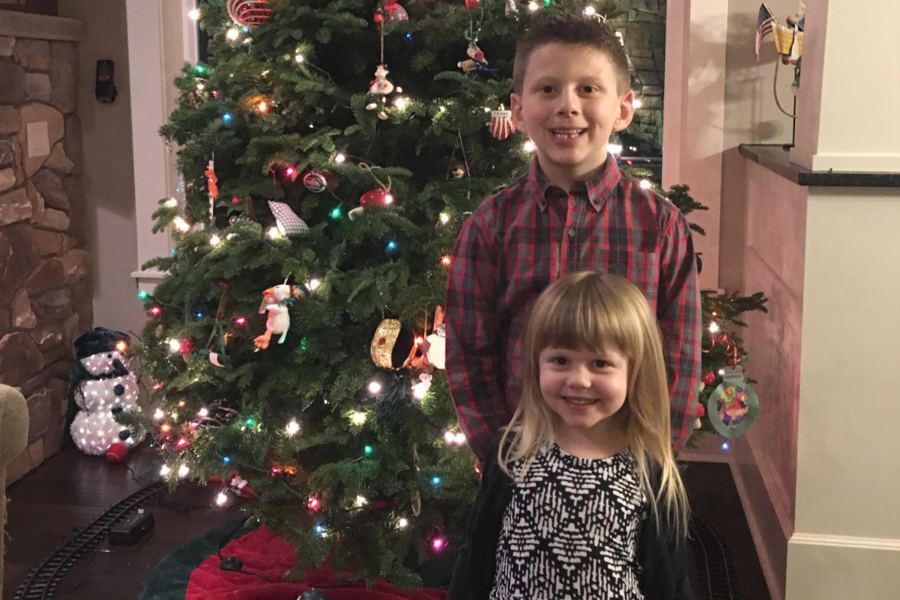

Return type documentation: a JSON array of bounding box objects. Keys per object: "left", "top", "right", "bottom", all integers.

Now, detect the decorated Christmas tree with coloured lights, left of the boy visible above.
[{"left": 132, "top": 0, "right": 768, "bottom": 586}]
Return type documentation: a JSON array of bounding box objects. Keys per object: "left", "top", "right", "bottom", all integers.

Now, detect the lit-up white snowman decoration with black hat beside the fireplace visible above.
[{"left": 69, "top": 327, "right": 145, "bottom": 463}]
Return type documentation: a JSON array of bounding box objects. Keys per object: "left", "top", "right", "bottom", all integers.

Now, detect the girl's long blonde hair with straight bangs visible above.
[{"left": 498, "top": 271, "right": 689, "bottom": 534}]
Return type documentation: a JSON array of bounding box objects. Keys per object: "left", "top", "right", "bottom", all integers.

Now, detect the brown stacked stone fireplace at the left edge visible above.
[{"left": 0, "top": 37, "right": 93, "bottom": 481}]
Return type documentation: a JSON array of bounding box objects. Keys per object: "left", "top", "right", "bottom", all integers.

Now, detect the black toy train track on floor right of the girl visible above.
[{"left": 688, "top": 514, "right": 741, "bottom": 600}]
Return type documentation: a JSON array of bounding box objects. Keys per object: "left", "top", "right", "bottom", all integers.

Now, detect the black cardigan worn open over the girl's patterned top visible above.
[{"left": 446, "top": 436, "right": 694, "bottom": 600}]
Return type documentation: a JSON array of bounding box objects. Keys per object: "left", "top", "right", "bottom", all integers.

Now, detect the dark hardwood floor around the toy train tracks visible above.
[{"left": 3, "top": 444, "right": 769, "bottom": 600}]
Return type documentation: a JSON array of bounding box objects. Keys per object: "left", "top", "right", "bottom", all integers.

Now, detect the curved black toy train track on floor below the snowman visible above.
[{"left": 14, "top": 482, "right": 165, "bottom": 600}]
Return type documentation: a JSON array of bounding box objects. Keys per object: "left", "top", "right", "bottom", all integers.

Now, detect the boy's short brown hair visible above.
[{"left": 513, "top": 13, "right": 631, "bottom": 94}]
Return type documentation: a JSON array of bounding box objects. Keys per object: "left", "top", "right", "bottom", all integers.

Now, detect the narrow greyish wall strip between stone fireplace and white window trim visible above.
[{"left": 59, "top": 0, "right": 145, "bottom": 332}]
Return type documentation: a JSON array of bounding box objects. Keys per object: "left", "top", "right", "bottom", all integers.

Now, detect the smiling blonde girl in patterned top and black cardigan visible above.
[{"left": 447, "top": 272, "right": 693, "bottom": 600}]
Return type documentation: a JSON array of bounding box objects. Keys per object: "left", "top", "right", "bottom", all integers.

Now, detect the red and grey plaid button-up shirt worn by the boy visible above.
[{"left": 445, "top": 156, "right": 701, "bottom": 458}]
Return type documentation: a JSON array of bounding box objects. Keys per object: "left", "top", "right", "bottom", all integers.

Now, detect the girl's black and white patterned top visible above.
[{"left": 491, "top": 444, "right": 647, "bottom": 600}]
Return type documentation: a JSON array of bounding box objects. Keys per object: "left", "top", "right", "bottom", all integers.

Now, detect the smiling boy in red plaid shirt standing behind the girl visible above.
[{"left": 445, "top": 15, "right": 701, "bottom": 460}]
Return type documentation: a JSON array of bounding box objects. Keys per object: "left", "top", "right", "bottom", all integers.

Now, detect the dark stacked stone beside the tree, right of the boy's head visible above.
[{"left": 609, "top": 0, "right": 666, "bottom": 154}]
